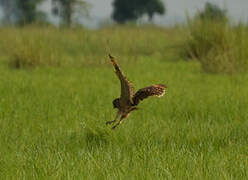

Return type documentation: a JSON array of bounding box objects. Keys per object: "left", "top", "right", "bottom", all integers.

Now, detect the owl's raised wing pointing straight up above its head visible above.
[{"left": 109, "top": 54, "right": 134, "bottom": 104}]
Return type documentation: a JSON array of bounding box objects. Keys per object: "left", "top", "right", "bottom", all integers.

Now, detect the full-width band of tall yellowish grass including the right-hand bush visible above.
[{"left": 0, "top": 19, "right": 248, "bottom": 74}]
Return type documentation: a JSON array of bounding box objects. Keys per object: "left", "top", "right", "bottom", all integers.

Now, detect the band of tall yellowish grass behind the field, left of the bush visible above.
[{"left": 0, "top": 26, "right": 181, "bottom": 68}]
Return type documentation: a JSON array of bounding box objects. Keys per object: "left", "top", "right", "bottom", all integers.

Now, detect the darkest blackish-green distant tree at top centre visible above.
[{"left": 112, "top": 0, "right": 166, "bottom": 23}]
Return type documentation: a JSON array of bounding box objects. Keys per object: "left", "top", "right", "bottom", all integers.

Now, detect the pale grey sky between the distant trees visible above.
[{"left": 0, "top": 0, "right": 248, "bottom": 28}]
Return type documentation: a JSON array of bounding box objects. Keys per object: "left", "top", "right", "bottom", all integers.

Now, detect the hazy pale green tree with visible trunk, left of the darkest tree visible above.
[{"left": 52, "top": 0, "right": 89, "bottom": 26}]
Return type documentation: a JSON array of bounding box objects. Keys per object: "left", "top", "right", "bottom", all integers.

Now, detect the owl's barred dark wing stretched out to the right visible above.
[{"left": 133, "top": 84, "right": 167, "bottom": 106}]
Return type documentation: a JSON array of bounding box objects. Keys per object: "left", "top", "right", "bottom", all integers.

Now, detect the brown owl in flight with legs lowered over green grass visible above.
[{"left": 106, "top": 55, "right": 167, "bottom": 129}]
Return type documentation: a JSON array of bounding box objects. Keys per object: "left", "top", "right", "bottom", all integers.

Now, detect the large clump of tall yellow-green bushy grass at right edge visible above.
[{"left": 184, "top": 18, "right": 248, "bottom": 73}]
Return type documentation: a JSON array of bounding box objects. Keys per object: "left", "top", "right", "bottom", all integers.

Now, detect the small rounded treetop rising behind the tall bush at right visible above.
[{"left": 199, "top": 2, "right": 227, "bottom": 20}]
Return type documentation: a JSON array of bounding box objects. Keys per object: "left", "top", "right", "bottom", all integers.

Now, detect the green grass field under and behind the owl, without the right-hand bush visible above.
[{"left": 0, "top": 28, "right": 248, "bottom": 180}]
